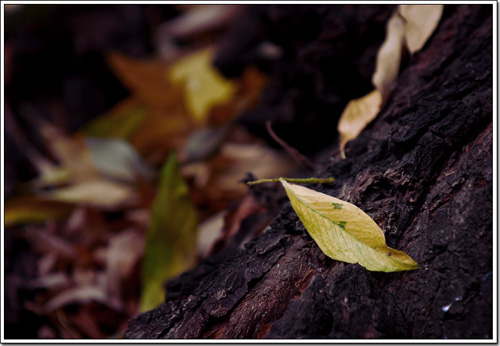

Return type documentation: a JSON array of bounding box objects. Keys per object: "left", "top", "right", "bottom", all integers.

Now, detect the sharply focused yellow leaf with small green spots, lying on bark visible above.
[{"left": 280, "top": 179, "right": 419, "bottom": 272}]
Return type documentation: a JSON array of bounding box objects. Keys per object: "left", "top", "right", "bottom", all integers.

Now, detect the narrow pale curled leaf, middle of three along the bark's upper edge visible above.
[{"left": 372, "top": 12, "right": 405, "bottom": 101}]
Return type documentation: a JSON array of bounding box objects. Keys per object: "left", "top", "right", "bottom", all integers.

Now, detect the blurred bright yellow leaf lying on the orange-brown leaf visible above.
[{"left": 169, "top": 50, "right": 234, "bottom": 122}]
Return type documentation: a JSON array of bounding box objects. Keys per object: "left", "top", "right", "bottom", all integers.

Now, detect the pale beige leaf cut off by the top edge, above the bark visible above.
[{"left": 399, "top": 5, "right": 444, "bottom": 54}]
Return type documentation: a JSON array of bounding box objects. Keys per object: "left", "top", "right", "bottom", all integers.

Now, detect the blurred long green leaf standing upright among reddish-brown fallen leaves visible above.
[{"left": 140, "top": 153, "right": 198, "bottom": 311}]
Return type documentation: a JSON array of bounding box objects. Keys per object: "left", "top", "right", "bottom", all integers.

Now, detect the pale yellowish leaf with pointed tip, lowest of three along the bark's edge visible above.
[{"left": 337, "top": 90, "right": 382, "bottom": 158}]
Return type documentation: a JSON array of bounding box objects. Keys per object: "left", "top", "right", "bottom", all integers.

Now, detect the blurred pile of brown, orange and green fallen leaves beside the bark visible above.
[{"left": 5, "top": 6, "right": 293, "bottom": 338}]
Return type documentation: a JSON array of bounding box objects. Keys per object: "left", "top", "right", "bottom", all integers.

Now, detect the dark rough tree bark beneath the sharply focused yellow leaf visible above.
[{"left": 125, "top": 5, "right": 493, "bottom": 338}]
